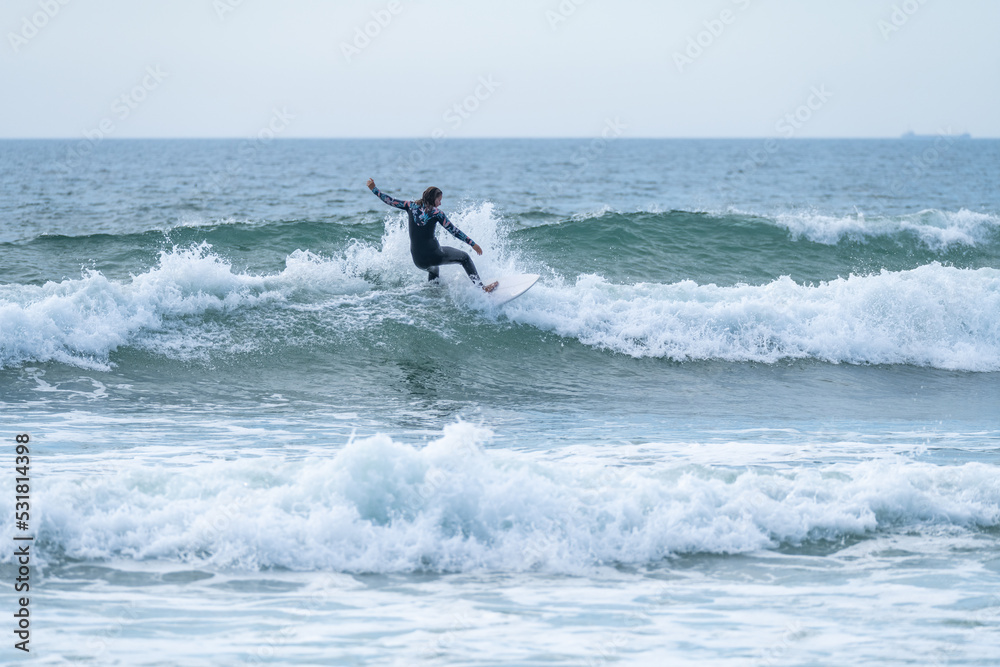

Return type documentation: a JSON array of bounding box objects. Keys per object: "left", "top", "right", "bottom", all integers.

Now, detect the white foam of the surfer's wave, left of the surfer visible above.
[{"left": 0, "top": 243, "right": 370, "bottom": 370}]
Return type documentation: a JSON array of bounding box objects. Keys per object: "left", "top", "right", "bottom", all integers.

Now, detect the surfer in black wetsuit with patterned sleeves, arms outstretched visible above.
[{"left": 367, "top": 178, "right": 498, "bottom": 292}]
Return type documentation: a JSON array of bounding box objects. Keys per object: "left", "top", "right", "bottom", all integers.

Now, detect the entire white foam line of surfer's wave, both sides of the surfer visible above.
[{"left": 0, "top": 202, "right": 1000, "bottom": 371}]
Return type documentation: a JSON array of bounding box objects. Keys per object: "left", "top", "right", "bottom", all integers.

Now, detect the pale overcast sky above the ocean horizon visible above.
[{"left": 0, "top": 0, "right": 1000, "bottom": 138}]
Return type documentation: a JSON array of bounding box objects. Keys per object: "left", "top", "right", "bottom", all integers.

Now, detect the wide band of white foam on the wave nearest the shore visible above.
[{"left": 0, "top": 423, "right": 1000, "bottom": 572}]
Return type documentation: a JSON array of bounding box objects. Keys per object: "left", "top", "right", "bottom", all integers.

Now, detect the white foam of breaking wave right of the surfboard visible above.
[{"left": 505, "top": 263, "right": 1000, "bottom": 371}]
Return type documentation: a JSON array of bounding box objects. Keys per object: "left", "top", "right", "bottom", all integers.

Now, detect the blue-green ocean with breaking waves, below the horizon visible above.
[{"left": 0, "top": 134, "right": 1000, "bottom": 665}]
